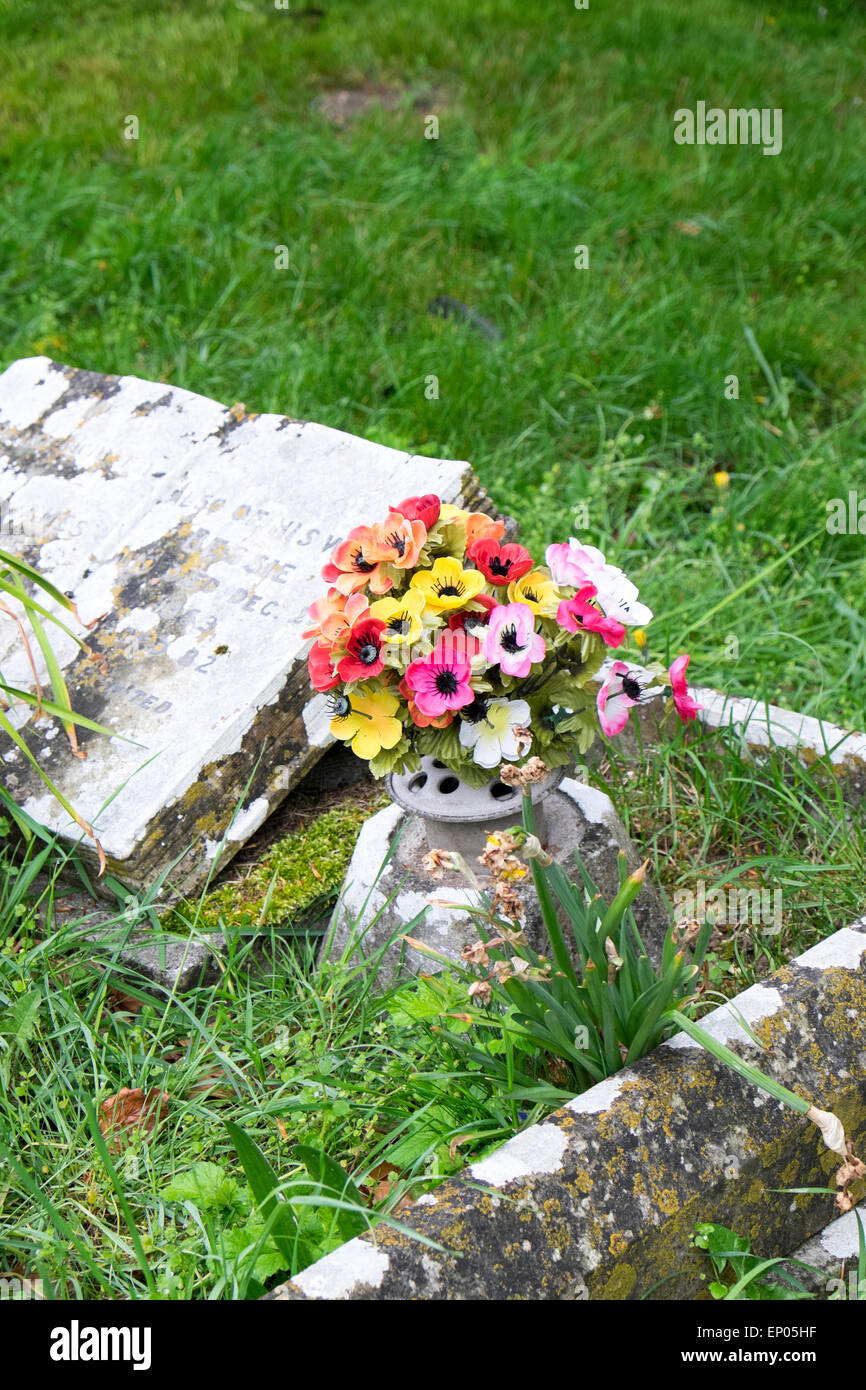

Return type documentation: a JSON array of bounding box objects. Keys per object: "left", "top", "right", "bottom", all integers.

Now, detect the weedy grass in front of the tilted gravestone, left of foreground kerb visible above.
[{"left": 0, "top": 824, "right": 549, "bottom": 1298}]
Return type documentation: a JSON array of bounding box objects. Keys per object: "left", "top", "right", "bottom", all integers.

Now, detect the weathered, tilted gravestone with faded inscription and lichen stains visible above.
[{"left": 0, "top": 357, "right": 485, "bottom": 891}]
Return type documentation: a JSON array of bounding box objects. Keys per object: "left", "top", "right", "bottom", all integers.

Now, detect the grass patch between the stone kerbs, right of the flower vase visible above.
[{"left": 592, "top": 730, "right": 866, "bottom": 995}]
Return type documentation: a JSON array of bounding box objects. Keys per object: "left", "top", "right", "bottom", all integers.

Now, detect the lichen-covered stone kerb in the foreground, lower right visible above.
[{"left": 265, "top": 919, "right": 866, "bottom": 1300}]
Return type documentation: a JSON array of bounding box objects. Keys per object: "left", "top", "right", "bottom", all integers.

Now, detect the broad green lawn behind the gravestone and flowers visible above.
[{"left": 0, "top": 0, "right": 866, "bottom": 726}]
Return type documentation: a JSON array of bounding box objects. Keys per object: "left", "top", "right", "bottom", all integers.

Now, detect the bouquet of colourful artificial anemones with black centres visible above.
[{"left": 304, "top": 493, "right": 699, "bottom": 785}]
